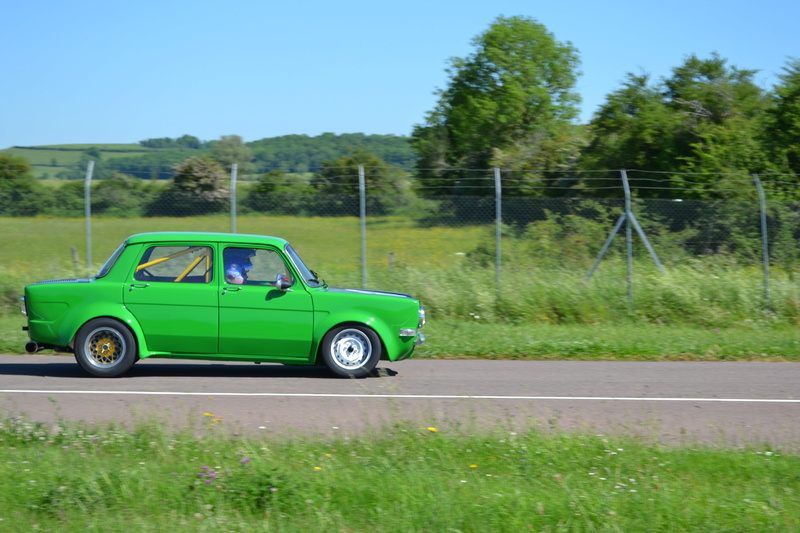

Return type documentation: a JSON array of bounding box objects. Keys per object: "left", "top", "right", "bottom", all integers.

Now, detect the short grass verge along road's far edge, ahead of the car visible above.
[{"left": 414, "top": 320, "right": 800, "bottom": 361}]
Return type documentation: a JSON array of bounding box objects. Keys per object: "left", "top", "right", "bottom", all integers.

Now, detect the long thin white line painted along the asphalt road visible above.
[{"left": 0, "top": 389, "right": 800, "bottom": 403}]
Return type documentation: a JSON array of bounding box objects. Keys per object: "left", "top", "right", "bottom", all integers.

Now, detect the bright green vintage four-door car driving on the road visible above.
[{"left": 23, "top": 232, "right": 425, "bottom": 378}]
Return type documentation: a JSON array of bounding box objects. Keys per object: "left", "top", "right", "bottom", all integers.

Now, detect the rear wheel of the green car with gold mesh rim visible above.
[{"left": 75, "top": 318, "right": 138, "bottom": 378}]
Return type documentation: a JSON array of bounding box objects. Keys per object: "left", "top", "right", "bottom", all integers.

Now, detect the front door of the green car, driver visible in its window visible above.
[{"left": 219, "top": 246, "right": 313, "bottom": 360}]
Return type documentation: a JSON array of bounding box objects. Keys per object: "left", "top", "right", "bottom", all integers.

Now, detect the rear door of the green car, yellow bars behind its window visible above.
[{"left": 123, "top": 243, "right": 219, "bottom": 354}]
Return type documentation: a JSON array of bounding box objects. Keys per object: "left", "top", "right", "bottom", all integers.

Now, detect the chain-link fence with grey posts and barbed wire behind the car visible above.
[{"left": 0, "top": 163, "right": 800, "bottom": 310}]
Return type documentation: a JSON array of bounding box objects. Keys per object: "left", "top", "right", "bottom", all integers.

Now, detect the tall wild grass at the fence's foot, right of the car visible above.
[{"left": 373, "top": 259, "right": 800, "bottom": 328}]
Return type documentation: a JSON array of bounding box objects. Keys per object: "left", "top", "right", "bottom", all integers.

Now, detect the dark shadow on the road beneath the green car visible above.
[{"left": 0, "top": 360, "right": 397, "bottom": 381}]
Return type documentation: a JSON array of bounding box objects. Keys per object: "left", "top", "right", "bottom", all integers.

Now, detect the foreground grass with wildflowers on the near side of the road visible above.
[{"left": 0, "top": 415, "right": 800, "bottom": 533}]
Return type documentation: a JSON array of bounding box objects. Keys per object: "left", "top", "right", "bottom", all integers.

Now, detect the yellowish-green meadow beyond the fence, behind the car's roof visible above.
[{"left": 0, "top": 215, "right": 485, "bottom": 278}]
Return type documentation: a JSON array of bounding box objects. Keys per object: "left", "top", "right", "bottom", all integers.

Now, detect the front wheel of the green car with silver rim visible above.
[{"left": 322, "top": 326, "right": 383, "bottom": 378}]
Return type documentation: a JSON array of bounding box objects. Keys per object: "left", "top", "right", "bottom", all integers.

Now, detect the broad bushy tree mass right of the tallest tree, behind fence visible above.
[{"left": 581, "top": 53, "right": 768, "bottom": 198}]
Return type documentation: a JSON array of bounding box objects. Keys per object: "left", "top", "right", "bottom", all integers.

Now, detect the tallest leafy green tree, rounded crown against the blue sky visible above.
[{"left": 412, "top": 17, "right": 579, "bottom": 195}]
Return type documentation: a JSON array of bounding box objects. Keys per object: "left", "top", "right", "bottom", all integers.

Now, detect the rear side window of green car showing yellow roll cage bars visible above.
[{"left": 133, "top": 246, "right": 213, "bottom": 283}]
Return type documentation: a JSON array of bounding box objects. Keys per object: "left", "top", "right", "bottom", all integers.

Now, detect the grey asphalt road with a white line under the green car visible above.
[{"left": 0, "top": 355, "right": 800, "bottom": 449}]
